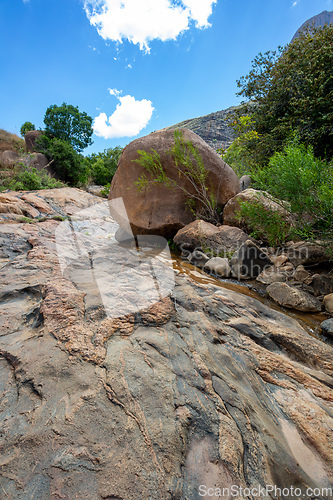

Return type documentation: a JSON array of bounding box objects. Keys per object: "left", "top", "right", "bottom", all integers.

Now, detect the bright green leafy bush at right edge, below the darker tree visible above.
[{"left": 240, "top": 140, "right": 333, "bottom": 244}]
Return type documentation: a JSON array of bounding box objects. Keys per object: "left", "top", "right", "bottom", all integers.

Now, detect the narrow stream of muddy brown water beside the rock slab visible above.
[{"left": 172, "top": 255, "right": 333, "bottom": 345}]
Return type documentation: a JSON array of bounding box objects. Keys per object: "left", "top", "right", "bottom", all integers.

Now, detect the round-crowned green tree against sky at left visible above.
[{"left": 44, "top": 102, "right": 93, "bottom": 152}]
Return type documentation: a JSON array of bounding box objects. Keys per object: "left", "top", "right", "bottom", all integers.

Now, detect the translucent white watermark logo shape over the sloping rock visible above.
[{"left": 55, "top": 198, "right": 175, "bottom": 319}]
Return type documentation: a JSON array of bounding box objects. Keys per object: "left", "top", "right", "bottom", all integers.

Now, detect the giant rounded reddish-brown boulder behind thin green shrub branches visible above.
[{"left": 109, "top": 129, "right": 240, "bottom": 238}]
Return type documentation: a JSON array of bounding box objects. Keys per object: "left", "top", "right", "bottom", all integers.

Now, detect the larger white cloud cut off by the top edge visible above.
[{"left": 84, "top": 0, "right": 217, "bottom": 52}]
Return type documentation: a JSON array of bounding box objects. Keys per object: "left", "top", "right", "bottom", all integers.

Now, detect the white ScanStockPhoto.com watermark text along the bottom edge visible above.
[{"left": 199, "top": 484, "right": 333, "bottom": 500}]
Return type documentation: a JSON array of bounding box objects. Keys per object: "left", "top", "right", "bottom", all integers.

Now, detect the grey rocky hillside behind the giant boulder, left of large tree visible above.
[{"left": 167, "top": 106, "right": 235, "bottom": 150}]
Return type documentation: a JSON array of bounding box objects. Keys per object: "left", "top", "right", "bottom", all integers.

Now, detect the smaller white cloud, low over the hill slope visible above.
[{"left": 93, "top": 89, "right": 154, "bottom": 139}]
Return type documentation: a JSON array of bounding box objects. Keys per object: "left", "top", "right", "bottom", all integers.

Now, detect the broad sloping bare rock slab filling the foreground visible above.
[{"left": 0, "top": 188, "right": 333, "bottom": 500}]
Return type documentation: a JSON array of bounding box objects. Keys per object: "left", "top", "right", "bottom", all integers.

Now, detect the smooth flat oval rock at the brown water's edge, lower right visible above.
[{"left": 266, "top": 283, "right": 321, "bottom": 312}]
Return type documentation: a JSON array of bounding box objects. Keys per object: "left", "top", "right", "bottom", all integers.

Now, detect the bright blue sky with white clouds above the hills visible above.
[{"left": 0, "top": 0, "right": 333, "bottom": 154}]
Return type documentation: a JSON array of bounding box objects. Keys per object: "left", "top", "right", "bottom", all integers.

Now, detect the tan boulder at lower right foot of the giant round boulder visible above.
[{"left": 173, "top": 220, "right": 249, "bottom": 256}]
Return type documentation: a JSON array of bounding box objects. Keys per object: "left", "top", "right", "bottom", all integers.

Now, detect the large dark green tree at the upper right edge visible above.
[{"left": 232, "top": 25, "right": 333, "bottom": 165}]
